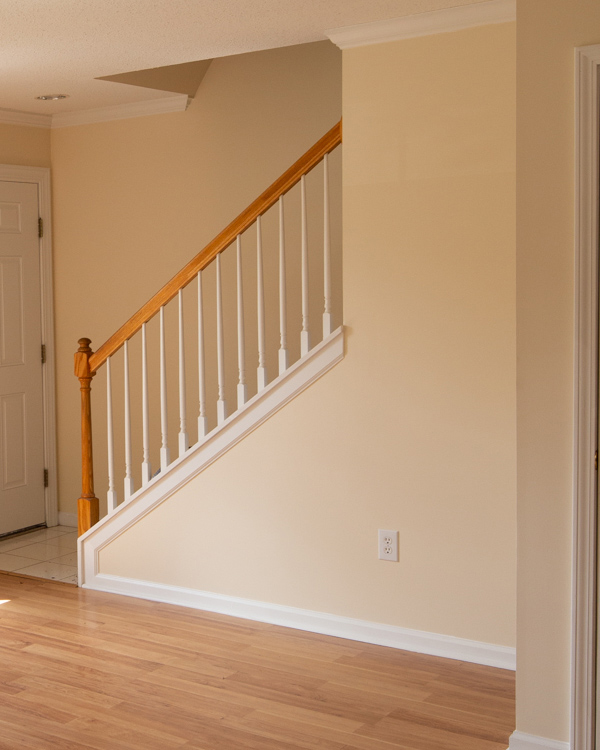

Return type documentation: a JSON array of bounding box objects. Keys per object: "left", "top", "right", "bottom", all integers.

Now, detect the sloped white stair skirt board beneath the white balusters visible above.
[{"left": 77, "top": 326, "right": 344, "bottom": 588}]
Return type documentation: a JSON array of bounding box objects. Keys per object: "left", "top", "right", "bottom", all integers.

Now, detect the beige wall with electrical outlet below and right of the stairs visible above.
[{"left": 100, "top": 24, "right": 516, "bottom": 646}]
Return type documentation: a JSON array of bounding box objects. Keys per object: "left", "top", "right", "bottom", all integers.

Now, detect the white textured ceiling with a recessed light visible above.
[{"left": 0, "top": 0, "right": 481, "bottom": 114}]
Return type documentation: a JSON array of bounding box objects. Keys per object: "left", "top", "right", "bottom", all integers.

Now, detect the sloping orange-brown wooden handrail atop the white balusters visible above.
[{"left": 89, "top": 120, "right": 342, "bottom": 371}]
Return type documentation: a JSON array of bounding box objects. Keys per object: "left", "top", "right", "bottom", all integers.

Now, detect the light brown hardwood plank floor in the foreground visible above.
[{"left": 0, "top": 574, "right": 514, "bottom": 750}]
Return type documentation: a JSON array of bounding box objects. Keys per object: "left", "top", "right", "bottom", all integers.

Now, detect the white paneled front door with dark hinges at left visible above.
[{"left": 0, "top": 182, "right": 46, "bottom": 534}]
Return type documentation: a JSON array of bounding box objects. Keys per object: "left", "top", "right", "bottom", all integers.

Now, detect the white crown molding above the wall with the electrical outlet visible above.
[{"left": 325, "top": 0, "right": 517, "bottom": 49}]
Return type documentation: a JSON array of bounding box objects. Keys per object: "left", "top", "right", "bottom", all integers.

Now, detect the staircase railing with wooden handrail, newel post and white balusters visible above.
[{"left": 75, "top": 122, "right": 342, "bottom": 535}]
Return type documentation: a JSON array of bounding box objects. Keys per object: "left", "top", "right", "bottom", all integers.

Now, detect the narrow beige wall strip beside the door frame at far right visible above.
[{"left": 517, "top": 0, "right": 600, "bottom": 741}]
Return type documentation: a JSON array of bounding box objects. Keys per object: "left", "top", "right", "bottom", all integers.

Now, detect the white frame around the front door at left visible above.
[{"left": 0, "top": 164, "right": 58, "bottom": 526}]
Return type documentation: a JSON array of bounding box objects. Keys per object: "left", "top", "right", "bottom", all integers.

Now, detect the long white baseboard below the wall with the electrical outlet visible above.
[{"left": 84, "top": 573, "right": 516, "bottom": 672}]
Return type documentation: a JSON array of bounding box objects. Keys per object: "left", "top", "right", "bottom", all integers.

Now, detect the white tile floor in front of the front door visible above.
[{"left": 0, "top": 526, "right": 77, "bottom": 583}]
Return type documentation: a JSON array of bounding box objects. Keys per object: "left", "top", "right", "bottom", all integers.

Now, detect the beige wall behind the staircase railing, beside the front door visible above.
[{"left": 52, "top": 42, "right": 341, "bottom": 512}]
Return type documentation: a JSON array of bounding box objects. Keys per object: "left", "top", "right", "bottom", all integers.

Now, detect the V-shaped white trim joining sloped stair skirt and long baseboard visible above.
[{"left": 78, "top": 327, "right": 516, "bottom": 670}]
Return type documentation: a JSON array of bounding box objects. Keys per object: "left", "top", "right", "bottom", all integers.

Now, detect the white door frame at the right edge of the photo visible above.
[{"left": 571, "top": 44, "right": 600, "bottom": 750}]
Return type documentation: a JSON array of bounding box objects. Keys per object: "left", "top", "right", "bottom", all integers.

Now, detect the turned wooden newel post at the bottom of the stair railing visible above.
[{"left": 75, "top": 339, "right": 100, "bottom": 536}]
